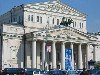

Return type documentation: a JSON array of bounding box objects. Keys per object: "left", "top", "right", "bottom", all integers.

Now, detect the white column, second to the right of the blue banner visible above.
[{"left": 78, "top": 43, "right": 83, "bottom": 69}]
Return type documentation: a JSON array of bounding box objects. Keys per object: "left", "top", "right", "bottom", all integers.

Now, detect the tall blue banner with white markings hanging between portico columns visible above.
[{"left": 65, "top": 48, "right": 72, "bottom": 70}]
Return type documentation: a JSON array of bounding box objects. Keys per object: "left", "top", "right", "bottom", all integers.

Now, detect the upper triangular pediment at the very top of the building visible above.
[{"left": 26, "top": 1, "right": 86, "bottom": 16}]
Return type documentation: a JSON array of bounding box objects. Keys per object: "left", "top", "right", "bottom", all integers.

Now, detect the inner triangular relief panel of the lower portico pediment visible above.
[{"left": 48, "top": 28, "right": 89, "bottom": 40}]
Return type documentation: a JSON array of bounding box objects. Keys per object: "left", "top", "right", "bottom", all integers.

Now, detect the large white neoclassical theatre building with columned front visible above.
[{"left": 0, "top": 0, "right": 100, "bottom": 70}]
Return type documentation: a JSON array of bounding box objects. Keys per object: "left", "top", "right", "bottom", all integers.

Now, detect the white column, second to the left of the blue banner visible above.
[{"left": 52, "top": 41, "right": 56, "bottom": 69}]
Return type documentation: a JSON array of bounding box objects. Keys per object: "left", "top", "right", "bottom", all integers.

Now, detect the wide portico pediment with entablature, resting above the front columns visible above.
[{"left": 28, "top": 27, "right": 97, "bottom": 43}]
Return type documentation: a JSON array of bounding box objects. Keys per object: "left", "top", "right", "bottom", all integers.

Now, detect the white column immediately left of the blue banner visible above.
[{"left": 61, "top": 42, "right": 65, "bottom": 70}]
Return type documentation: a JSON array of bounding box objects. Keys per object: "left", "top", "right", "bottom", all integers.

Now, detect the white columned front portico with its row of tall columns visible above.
[{"left": 27, "top": 26, "right": 95, "bottom": 70}]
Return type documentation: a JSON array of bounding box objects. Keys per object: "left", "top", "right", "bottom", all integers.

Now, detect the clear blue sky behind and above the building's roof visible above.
[{"left": 0, "top": 0, "right": 100, "bottom": 32}]
